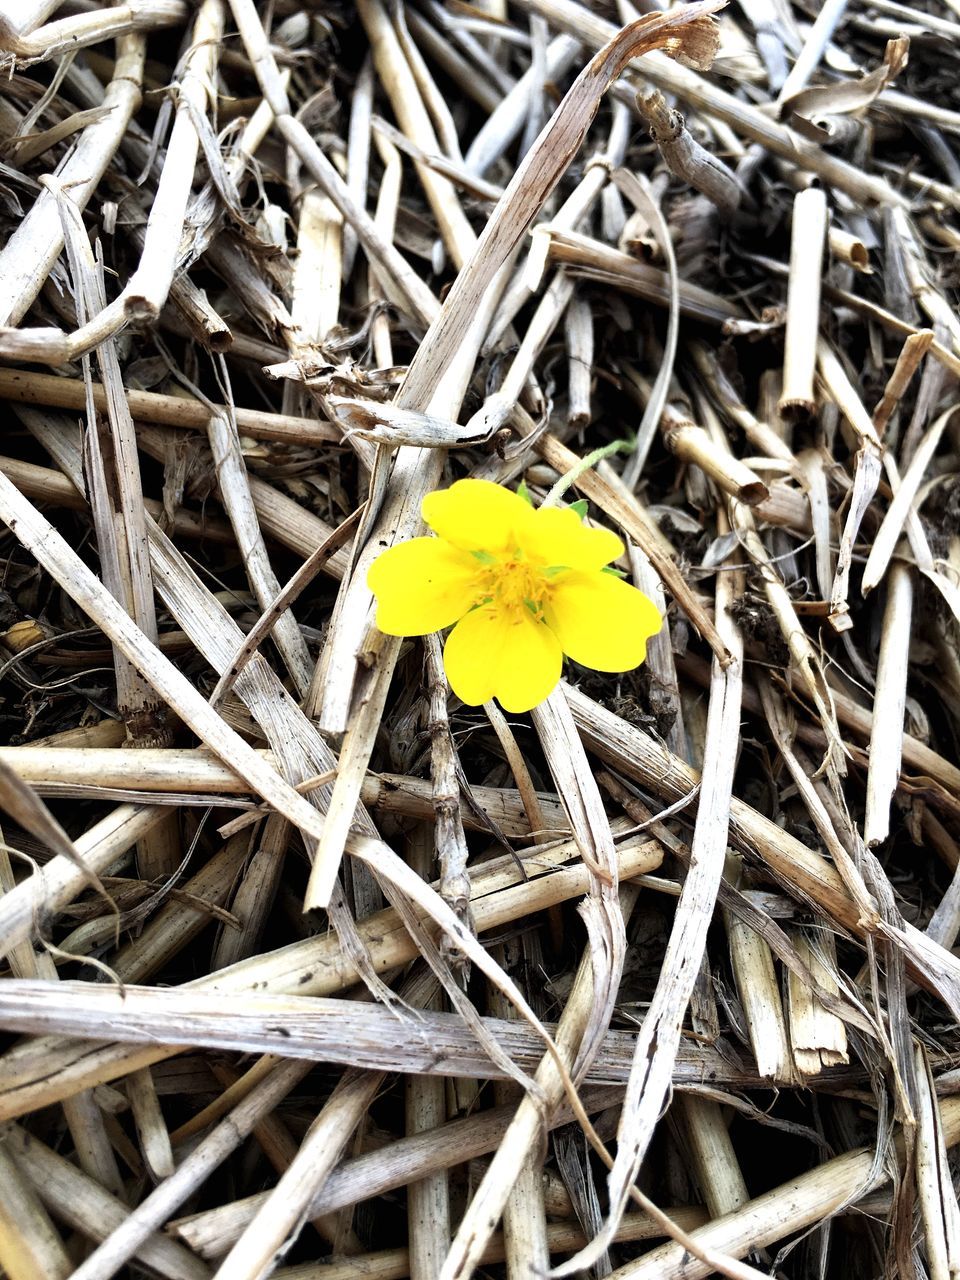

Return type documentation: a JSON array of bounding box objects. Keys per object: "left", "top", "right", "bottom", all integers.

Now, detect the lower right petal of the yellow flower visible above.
[{"left": 544, "top": 572, "right": 663, "bottom": 671}]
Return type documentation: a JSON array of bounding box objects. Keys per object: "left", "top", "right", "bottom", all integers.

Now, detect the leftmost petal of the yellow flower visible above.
[{"left": 366, "top": 538, "right": 479, "bottom": 636}]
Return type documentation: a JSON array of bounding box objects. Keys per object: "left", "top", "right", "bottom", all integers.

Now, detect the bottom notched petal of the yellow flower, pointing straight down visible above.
[{"left": 443, "top": 605, "right": 563, "bottom": 712}]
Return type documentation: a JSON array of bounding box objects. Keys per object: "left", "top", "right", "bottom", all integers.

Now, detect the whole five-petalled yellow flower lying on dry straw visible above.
[{"left": 367, "top": 480, "right": 662, "bottom": 712}]
